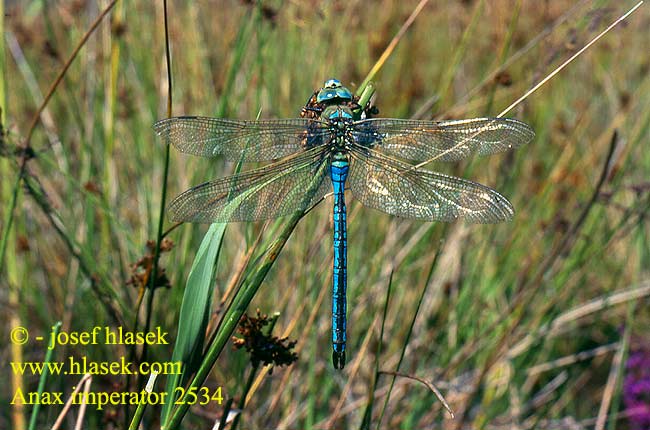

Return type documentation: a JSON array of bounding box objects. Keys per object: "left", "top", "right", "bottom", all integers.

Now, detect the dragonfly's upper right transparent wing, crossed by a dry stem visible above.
[{"left": 353, "top": 118, "right": 535, "bottom": 162}]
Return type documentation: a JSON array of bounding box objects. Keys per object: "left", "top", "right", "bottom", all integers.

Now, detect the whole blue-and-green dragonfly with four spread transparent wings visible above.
[{"left": 153, "top": 79, "right": 535, "bottom": 369}]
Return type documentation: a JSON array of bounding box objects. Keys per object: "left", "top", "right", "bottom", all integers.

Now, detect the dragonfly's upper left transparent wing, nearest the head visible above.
[{"left": 153, "top": 116, "right": 329, "bottom": 162}]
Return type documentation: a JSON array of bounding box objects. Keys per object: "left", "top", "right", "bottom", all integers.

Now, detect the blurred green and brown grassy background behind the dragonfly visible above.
[{"left": 0, "top": 0, "right": 650, "bottom": 429}]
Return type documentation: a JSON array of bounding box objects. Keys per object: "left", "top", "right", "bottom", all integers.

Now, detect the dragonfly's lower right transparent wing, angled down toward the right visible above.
[{"left": 348, "top": 146, "right": 514, "bottom": 224}]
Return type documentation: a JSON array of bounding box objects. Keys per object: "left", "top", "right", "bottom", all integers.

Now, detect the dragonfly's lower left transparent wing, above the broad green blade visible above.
[{"left": 167, "top": 148, "right": 331, "bottom": 223}]
